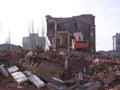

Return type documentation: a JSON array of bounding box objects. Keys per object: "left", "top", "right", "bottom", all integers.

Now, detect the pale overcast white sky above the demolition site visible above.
[{"left": 0, "top": 0, "right": 120, "bottom": 50}]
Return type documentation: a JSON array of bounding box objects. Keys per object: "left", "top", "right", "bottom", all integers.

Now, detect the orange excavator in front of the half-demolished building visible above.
[{"left": 72, "top": 32, "right": 89, "bottom": 50}]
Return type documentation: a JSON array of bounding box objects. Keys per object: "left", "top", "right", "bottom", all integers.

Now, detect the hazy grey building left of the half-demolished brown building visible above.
[{"left": 23, "top": 33, "right": 46, "bottom": 50}]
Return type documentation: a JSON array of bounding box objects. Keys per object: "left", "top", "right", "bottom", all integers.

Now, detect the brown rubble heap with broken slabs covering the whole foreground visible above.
[{"left": 0, "top": 48, "right": 120, "bottom": 90}]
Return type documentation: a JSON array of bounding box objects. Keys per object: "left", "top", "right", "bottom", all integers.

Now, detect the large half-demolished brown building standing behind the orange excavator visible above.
[{"left": 46, "top": 14, "right": 96, "bottom": 52}]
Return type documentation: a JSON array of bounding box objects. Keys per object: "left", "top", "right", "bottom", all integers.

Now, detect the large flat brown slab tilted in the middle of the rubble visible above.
[{"left": 31, "top": 60, "right": 64, "bottom": 82}]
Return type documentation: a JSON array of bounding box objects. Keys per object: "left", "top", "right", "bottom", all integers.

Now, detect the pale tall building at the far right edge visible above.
[{"left": 113, "top": 33, "right": 120, "bottom": 51}]
